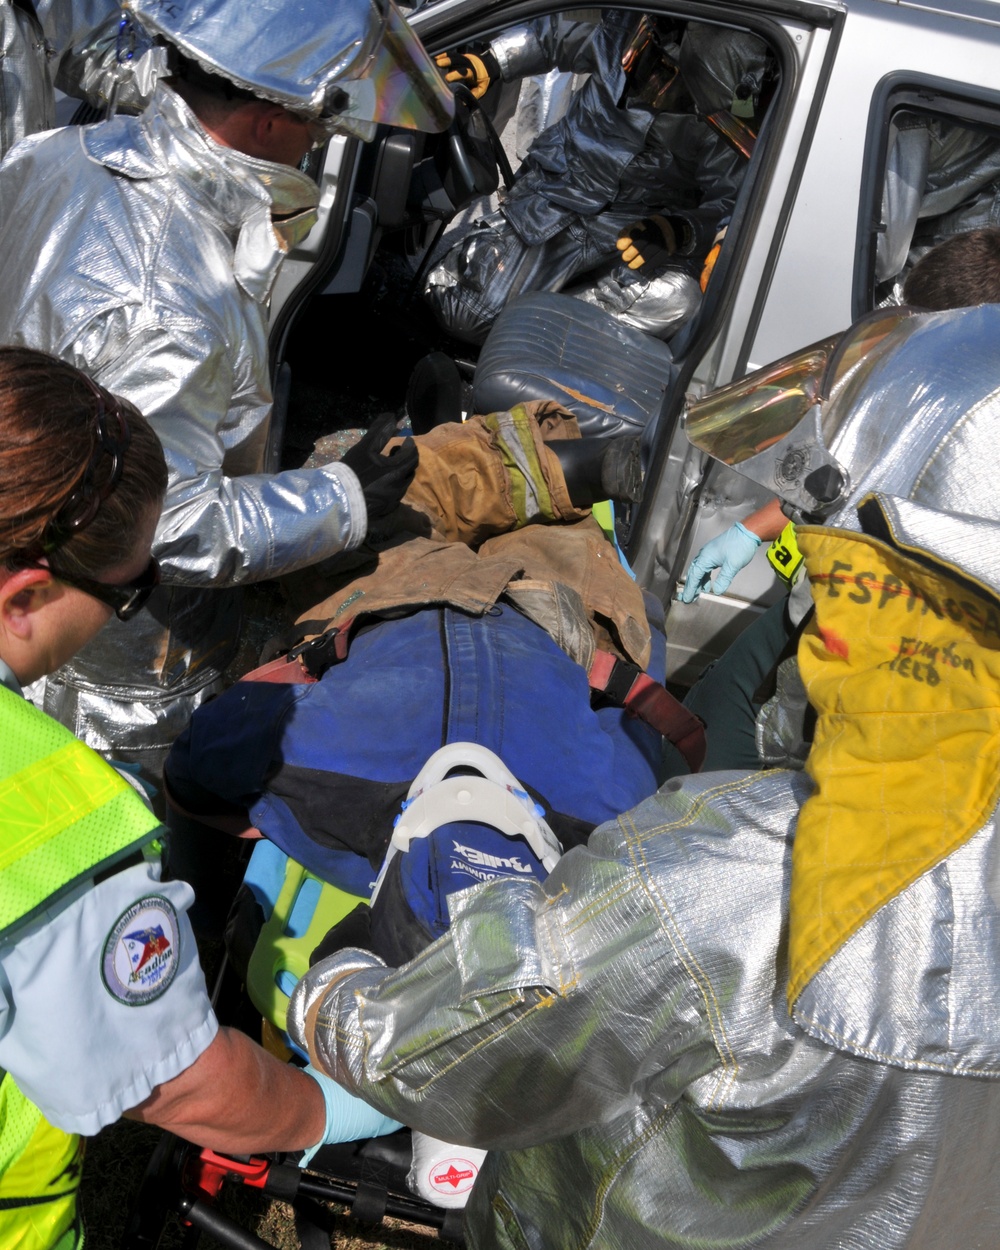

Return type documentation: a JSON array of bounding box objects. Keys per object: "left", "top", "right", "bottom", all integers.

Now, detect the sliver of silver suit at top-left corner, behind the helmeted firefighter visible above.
[{"left": 0, "top": 0, "right": 55, "bottom": 156}]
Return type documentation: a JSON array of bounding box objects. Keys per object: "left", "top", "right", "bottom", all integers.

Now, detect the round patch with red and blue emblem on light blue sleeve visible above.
[{"left": 101, "top": 894, "right": 180, "bottom": 1008}]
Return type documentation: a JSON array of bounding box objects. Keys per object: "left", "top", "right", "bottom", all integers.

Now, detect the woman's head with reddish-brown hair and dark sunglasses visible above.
[{"left": 0, "top": 348, "right": 166, "bottom": 681}]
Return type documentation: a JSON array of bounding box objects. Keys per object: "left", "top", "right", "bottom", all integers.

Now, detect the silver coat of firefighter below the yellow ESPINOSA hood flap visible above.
[{"left": 289, "top": 755, "right": 1000, "bottom": 1250}]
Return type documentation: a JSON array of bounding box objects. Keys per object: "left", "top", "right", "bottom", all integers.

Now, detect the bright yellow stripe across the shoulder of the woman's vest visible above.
[{"left": 0, "top": 739, "right": 123, "bottom": 873}]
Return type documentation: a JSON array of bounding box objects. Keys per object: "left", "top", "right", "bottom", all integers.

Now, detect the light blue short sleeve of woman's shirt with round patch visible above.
[{"left": 0, "top": 661, "right": 219, "bottom": 1136}]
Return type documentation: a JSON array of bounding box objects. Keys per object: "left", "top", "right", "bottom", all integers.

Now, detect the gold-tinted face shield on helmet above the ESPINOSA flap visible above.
[{"left": 685, "top": 308, "right": 916, "bottom": 518}]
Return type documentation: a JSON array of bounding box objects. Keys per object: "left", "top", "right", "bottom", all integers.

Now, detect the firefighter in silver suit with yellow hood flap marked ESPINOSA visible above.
[{"left": 289, "top": 305, "right": 1000, "bottom": 1250}]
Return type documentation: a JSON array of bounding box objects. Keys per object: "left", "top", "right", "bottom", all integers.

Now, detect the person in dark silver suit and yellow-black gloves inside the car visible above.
[{"left": 425, "top": 10, "right": 768, "bottom": 343}]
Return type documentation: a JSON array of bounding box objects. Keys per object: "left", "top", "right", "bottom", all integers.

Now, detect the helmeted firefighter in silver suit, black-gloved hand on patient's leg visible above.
[{"left": 0, "top": 0, "right": 453, "bottom": 776}]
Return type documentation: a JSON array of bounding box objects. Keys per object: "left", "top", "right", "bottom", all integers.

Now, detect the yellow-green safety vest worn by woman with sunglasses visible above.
[{"left": 0, "top": 688, "right": 158, "bottom": 1250}]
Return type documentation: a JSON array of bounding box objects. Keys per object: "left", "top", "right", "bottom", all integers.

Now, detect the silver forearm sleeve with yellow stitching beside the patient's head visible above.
[{"left": 295, "top": 826, "right": 718, "bottom": 1149}]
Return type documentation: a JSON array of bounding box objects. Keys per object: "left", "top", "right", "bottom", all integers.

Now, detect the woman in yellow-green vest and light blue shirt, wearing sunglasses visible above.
[{"left": 0, "top": 348, "right": 396, "bottom": 1250}]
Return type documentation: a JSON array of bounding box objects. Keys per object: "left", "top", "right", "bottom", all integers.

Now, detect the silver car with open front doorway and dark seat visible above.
[{"left": 271, "top": 0, "right": 1000, "bottom": 685}]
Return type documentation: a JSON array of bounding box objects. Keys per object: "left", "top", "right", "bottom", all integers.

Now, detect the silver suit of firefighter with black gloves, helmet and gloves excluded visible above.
[{"left": 0, "top": 85, "right": 366, "bottom": 750}]
